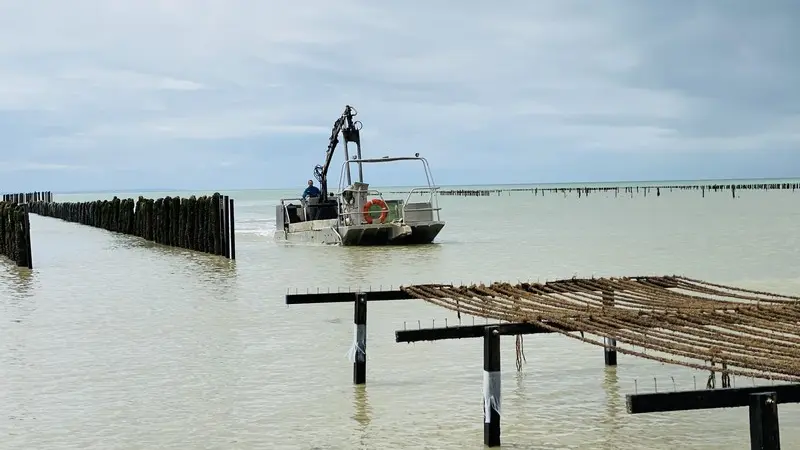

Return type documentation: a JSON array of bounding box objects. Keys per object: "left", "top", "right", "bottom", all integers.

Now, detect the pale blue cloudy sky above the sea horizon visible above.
[{"left": 0, "top": 0, "right": 800, "bottom": 192}]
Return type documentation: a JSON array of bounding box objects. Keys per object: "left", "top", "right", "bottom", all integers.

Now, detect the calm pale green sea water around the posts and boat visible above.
[{"left": 0, "top": 178, "right": 800, "bottom": 450}]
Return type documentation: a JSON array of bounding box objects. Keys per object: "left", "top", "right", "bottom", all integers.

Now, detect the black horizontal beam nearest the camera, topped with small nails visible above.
[{"left": 626, "top": 383, "right": 800, "bottom": 414}]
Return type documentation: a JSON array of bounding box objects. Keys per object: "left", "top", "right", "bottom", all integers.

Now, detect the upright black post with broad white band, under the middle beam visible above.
[{"left": 483, "top": 326, "right": 501, "bottom": 447}]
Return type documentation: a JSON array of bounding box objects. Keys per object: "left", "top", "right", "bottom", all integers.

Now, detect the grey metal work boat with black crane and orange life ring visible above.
[{"left": 275, "top": 105, "right": 445, "bottom": 246}]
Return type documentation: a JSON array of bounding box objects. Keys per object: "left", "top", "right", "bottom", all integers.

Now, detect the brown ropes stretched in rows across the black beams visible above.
[{"left": 401, "top": 276, "right": 800, "bottom": 381}]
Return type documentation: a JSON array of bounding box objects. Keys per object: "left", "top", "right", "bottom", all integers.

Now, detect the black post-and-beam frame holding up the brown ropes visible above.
[{"left": 286, "top": 276, "right": 800, "bottom": 450}]
